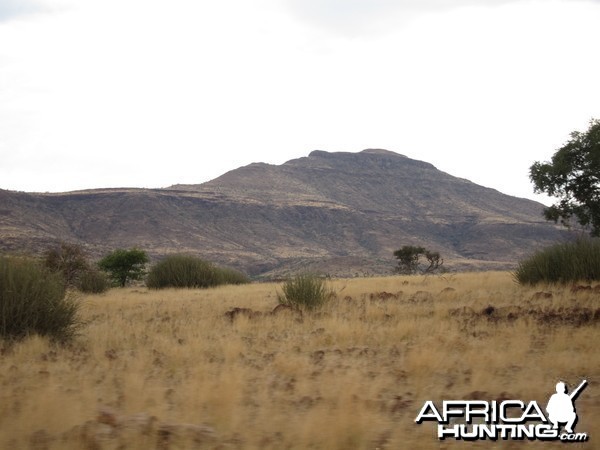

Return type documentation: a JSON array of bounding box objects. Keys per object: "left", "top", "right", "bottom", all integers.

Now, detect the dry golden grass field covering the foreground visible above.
[{"left": 0, "top": 272, "right": 600, "bottom": 450}]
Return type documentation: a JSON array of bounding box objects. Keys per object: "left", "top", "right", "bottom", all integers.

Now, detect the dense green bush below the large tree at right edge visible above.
[{"left": 514, "top": 238, "right": 600, "bottom": 284}]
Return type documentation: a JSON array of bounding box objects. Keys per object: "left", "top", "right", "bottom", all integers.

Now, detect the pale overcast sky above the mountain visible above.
[{"left": 0, "top": 0, "right": 600, "bottom": 199}]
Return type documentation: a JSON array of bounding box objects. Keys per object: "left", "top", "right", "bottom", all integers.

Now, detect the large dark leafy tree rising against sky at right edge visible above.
[{"left": 529, "top": 119, "right": 600, "bottom": 237}]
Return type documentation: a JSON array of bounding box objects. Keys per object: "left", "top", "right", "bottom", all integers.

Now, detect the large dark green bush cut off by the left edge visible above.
[{"left": 0, "top": 257, "right": 79, "bottom": 342}]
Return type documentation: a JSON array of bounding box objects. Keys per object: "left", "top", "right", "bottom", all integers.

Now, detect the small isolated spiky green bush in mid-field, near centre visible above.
[{"left": 277, "top": 273, "right": 333, "bottom": 310}]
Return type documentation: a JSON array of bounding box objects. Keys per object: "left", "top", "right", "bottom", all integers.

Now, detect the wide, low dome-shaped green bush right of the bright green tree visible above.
[{"left": 146, "top": 255, "right": 250, "bottom": 289}]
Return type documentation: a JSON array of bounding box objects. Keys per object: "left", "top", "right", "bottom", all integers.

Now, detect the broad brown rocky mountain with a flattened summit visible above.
[{"left": 0, "top": 149, "right": 561, "bottom": 276}]
